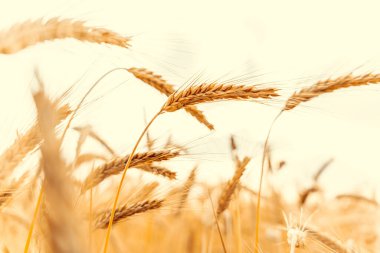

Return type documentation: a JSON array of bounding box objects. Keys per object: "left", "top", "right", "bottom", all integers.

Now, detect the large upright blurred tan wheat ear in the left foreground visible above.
[{"left": 33, "top": 88, "right": 85, "bottom": 253}]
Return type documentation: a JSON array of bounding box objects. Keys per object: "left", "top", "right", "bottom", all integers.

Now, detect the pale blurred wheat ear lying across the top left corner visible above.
[{"left": 0, "top": 17, "right": 130, "bottom": 54}]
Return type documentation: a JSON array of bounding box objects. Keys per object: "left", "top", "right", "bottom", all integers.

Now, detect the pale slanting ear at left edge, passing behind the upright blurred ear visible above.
[{"left": 0, "top": 102, "right": 71, "bottom": 180}]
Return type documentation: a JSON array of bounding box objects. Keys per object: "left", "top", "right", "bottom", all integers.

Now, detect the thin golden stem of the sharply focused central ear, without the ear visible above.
[{"left": 103, "top": 110, "right": 162, "bottom": 253}]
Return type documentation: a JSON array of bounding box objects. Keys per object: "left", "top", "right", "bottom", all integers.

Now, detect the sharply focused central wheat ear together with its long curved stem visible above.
[{"left": 103, "top": 83, "right": 278, "bottom": 253}]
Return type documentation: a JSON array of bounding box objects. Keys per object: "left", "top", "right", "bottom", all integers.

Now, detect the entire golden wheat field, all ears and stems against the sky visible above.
[{"left": 0, "top": 1, "right": 380, "bottom": 253}]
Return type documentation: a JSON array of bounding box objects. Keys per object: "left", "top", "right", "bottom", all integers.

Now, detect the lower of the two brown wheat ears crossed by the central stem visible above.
[{"left": 95, "top": 200, "right": 164, "bottom": 229}]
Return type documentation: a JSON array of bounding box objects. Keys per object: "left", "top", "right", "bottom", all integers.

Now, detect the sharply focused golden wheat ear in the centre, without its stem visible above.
[{"left": 162, "top": 83, "right": 278, "bottom": 112}]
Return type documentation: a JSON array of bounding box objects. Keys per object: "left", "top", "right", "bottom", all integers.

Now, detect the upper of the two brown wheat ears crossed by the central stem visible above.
[{"left": 82, "top": 150, "right": 179, "bottom": 192}]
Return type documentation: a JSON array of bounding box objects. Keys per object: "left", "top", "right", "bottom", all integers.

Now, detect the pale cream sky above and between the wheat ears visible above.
[{"left": 0, "top": 0, "right": 380, "bottom": 202}]
